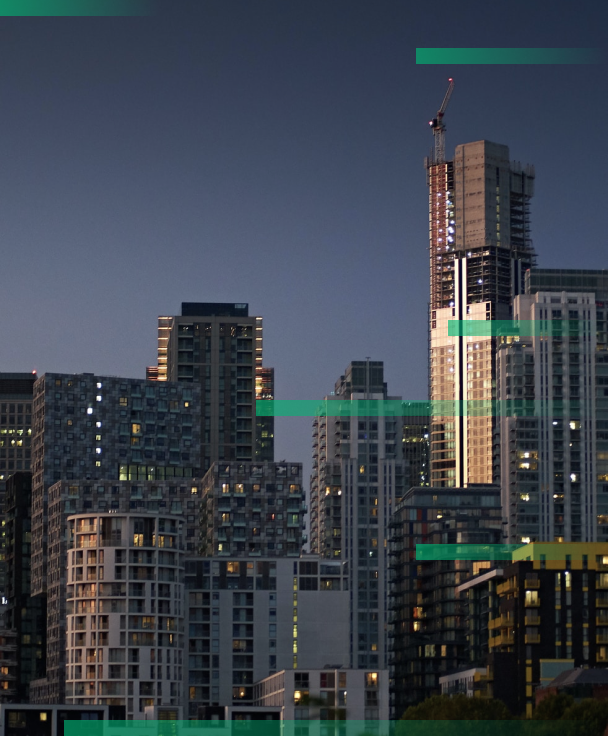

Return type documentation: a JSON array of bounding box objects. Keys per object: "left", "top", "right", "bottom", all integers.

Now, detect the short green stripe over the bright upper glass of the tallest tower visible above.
[{"left": 448, "top": 319, "right": 579, "bottom": 337}]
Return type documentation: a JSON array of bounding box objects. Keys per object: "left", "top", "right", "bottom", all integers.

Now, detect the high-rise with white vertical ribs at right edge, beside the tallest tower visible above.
[{"left": 497, "top": 269, "right": 608, "bottom": 542}]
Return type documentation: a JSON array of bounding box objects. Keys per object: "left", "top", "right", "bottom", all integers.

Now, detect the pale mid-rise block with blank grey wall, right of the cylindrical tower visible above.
[{"left": 186, "top": 555, "right": 350, "bottom": 717}]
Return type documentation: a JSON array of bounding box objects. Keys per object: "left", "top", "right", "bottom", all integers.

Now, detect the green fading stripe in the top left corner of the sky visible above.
[{"left": 0, "top": 0, "right": 157, "bottom": 17}]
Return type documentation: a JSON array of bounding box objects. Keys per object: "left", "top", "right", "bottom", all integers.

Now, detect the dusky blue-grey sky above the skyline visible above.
[{"left": 0, "top": 0, "right": 608, "bottom": 476}]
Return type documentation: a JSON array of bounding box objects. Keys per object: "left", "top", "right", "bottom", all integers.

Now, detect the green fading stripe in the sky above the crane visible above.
[{"left": 416, "top": 49, "right": 602, "bottom": 64}]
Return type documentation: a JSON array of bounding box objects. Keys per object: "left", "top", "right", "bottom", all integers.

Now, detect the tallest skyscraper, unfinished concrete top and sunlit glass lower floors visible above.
[{"left": 427, "top": 141, "right": 534, "bottom": 487}]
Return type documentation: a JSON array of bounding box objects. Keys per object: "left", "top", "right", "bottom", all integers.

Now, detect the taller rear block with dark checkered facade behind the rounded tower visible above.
[{"left": 32, "top": 373, "right": 200, "bottom": 595}]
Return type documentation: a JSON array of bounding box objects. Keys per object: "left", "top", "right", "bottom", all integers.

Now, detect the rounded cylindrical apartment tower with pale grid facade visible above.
[{"left": 65, "top": 512, "right": 184, "bottom": 720}]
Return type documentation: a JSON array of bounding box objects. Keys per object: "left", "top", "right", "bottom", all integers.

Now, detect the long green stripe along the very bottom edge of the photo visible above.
[{"left": 64, "top": 720, "right": 589, "bottom": 736}]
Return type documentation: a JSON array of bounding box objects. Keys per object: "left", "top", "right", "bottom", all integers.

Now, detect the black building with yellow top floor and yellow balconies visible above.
[{"left": 472, "top": 543, "right": 608, "bottom": 716}]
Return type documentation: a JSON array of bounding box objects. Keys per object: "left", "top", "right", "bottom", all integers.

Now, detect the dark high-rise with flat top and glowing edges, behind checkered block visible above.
[{"left": 147, "top": 302, "right": 274, "bottom": 474}]
